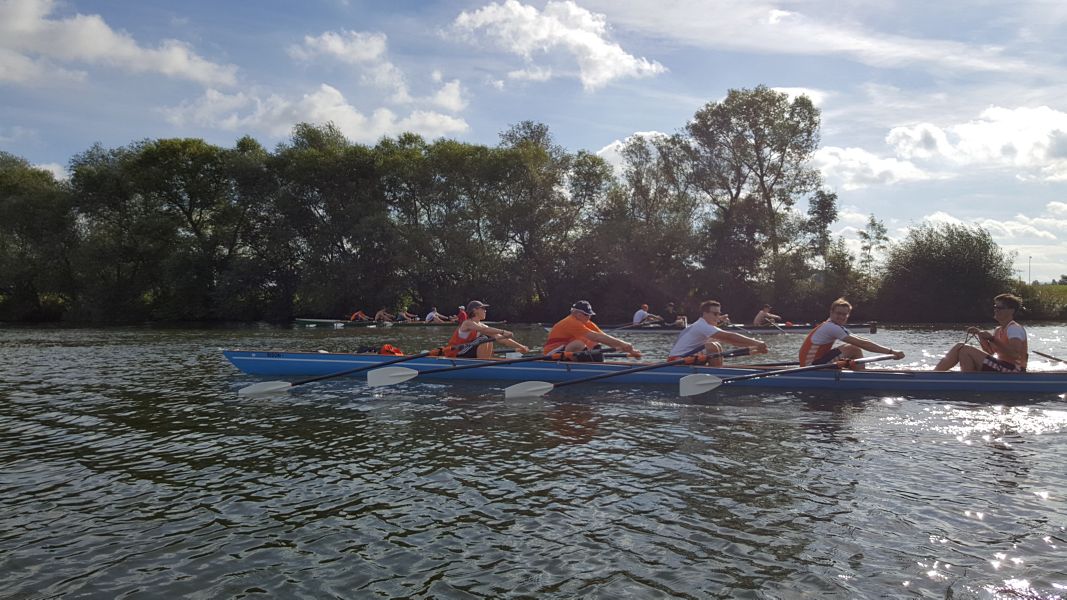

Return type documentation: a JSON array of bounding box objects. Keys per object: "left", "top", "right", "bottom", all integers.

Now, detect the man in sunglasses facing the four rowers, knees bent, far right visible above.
[{"left": 934, "top": 294, "right": 1030, "bottom": 373}]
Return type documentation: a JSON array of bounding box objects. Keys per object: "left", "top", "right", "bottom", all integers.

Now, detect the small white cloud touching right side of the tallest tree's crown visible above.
[{"left": 814, "top": 146, "right": 943, "bottom": 190}]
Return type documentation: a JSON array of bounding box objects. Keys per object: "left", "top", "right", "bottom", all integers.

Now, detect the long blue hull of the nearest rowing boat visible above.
[{"left": 223, "top": 350, "right": 1067, "bottom": 394}]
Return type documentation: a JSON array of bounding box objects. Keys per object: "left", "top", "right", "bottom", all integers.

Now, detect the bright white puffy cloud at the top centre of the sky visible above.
[{"left": 452, "top": 0, "right": 667, "bottom": 91}]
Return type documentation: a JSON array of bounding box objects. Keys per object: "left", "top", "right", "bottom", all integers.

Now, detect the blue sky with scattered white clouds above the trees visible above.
[{"left": 0, "top": 0, "right": 1067, "bottom": 282}]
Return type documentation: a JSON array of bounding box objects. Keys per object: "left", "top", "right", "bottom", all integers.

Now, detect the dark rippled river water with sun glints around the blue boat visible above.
[{"left": 0, "top": 325, "right": 1067, "bottom": 599}]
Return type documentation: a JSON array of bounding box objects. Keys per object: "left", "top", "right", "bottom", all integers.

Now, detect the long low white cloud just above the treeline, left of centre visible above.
[{"left": 163, "top": 83, "right": 469, "bottom": 143}]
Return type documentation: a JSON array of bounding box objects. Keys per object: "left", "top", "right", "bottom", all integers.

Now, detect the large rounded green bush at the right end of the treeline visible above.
[{"left": 879, "top": 224, "right": 1019, "bottom": 322}]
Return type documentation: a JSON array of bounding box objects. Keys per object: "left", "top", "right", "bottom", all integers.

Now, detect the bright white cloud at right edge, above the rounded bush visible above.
[{"left": 886, "top": 107, "right": 1067, "bottom": 181}]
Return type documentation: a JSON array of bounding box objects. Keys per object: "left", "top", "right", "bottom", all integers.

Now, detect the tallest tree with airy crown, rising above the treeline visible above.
[{"left": 686, "top": 85, "right": 830, "bottom": 297}]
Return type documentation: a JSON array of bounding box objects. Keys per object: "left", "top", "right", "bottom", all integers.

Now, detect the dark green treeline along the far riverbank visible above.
[{"left": 0, "top": 86, "right": 1058, "bottom": 322}]
